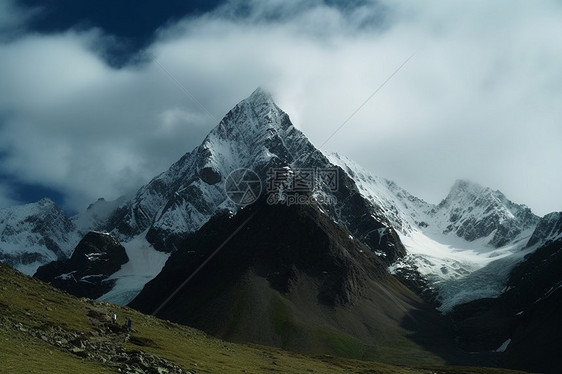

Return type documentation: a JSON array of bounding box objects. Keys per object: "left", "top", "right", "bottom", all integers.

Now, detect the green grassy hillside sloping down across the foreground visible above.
[{"left": 0, "top": 264, "right": 532, "bottom": 374}]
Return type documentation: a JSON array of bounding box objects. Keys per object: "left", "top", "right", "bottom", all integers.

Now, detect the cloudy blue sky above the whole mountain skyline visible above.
[{"left": 0, "top": 0, "right": 562, "bottom": 215}]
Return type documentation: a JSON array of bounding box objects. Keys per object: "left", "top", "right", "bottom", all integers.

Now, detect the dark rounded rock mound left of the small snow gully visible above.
[{"left": 35, "top": 232, "right": 129, "bottom": 299}]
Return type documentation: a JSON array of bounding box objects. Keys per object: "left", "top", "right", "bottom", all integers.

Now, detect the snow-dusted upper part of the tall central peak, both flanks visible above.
[{"left": 99, "top": 89, "right": 400, "bottom": 259}]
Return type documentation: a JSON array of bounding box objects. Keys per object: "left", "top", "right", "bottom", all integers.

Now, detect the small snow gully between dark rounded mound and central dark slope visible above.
[{"left": 98, "top": 233, "right": 169, "bottom": 305}]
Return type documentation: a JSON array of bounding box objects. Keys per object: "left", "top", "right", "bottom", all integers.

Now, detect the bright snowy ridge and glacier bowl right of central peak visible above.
[{"left": 328, "top": 154, "right": 539, "bottom": 312}]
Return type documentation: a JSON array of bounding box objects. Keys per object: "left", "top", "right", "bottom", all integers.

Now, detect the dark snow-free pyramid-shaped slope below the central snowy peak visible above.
[{"left": 130, "top": 201, "right": 459, "bottom": 362}]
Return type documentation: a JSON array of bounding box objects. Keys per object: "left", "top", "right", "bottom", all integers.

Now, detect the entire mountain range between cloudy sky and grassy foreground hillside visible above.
[{"left": 0, "top": 89, "right": 562, "bottom": 372}]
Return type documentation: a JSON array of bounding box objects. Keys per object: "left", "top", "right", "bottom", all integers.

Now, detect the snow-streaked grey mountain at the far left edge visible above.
[{"left": 0, "top": 198, "right": 80, "bottom": 274}]
